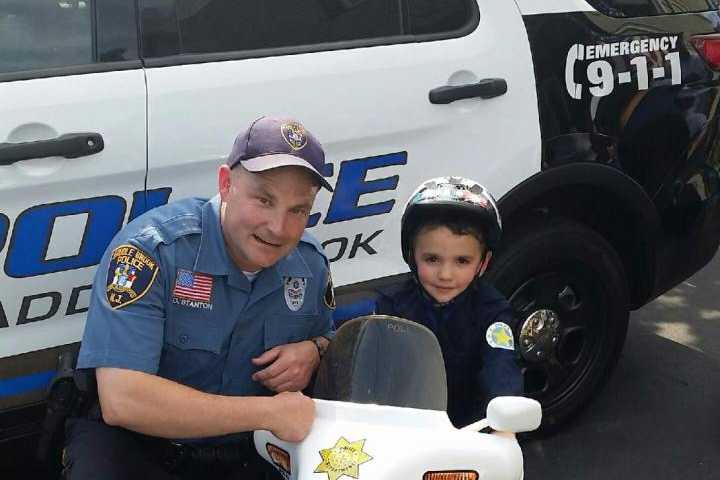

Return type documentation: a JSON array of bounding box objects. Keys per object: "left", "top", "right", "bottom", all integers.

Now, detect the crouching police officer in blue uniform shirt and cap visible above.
[{"left": 64, "top": 117, "right": 334, "bottom": 479}]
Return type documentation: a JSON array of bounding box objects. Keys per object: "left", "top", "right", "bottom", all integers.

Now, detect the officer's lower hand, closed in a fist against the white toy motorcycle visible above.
[{"left": 268, "top": 392, "right": 315, "bottom": 442}]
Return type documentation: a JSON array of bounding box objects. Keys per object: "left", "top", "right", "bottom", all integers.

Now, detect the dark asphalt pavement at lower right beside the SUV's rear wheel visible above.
[{"left": 523, "top": 255, "right": 720, "bottom": 480}]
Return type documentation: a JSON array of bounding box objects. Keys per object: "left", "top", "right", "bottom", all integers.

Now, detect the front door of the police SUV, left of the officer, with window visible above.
[{"left": 0, "top": 0, "right": 146, "bottom": 368}]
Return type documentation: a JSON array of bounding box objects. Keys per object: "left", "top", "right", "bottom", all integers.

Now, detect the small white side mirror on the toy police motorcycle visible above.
[{"left": 486, "top": 397, "right": 542, "bottom": 433}]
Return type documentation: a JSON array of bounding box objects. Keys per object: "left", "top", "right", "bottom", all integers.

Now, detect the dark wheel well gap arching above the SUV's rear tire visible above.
[{"left": 500, "top": 185, "right": 654, "bottom": 308}]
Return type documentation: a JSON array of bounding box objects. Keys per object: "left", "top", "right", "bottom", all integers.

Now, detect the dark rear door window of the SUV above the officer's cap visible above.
[{"left": 143, "top": 0, "right": 473, "bottom": 57}]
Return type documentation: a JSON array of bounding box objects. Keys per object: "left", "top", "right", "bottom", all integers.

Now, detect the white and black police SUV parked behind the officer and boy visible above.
[{"left": 0, "top": 0, "right": 720, "bottom": 439}]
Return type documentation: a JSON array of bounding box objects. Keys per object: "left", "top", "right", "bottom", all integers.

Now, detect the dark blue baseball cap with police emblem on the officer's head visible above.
[{"left": 227, "top": 117, "right": 333, "bottom": 192}]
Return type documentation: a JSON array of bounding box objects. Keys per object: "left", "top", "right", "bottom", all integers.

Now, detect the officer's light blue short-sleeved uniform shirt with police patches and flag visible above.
[{"left": 78, "top": 196, "right": 334, "bottom": 395}]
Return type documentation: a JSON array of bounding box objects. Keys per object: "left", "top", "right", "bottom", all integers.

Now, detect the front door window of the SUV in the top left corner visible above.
[{"left": 0, "top": 0, "right": 138, "bottom": 74}]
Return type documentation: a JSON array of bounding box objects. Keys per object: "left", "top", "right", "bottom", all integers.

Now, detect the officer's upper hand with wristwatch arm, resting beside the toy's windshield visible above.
[{"left": 252, "top": 341, "right": 320, "bottom": 392}]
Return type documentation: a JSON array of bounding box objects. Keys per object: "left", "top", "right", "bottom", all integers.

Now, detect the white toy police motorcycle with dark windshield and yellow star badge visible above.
[{"left": 254, "top": 315, "right": 541, "bottom": 480}]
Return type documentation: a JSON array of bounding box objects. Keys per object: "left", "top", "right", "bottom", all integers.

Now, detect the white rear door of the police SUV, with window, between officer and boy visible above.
[{"left": 141, "top": 0, "right": 539, "bottom": 284}]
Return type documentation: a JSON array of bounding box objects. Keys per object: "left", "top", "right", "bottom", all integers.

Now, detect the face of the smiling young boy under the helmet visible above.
[{"left": 414, "top": 227, "right": 486, "bottom": 303}]
